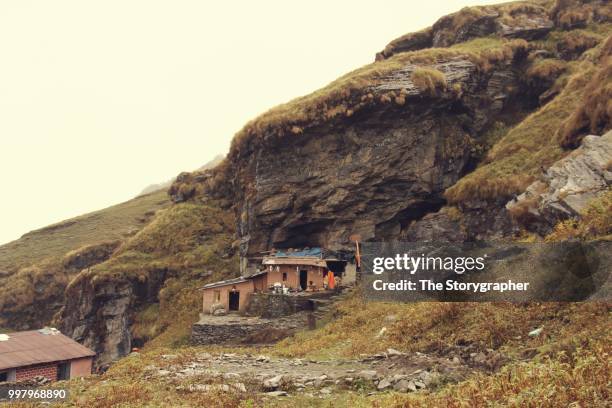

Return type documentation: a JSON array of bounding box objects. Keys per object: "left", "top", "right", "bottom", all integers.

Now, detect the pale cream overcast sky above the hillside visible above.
[{"left": 0, "top": 0, "right": 506, "bottom": 244}]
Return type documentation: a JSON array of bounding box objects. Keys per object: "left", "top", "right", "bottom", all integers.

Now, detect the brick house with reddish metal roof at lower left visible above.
[{"left": 0, "top": 328, "right": 96, "bottom": 382}]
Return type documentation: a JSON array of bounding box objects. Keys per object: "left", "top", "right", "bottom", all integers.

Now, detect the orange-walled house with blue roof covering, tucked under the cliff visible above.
[{"left": 201, "top": 248, "right": 355, "bottom": 313}]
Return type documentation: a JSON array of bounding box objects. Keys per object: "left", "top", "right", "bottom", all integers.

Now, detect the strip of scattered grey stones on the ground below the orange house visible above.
[{"left": 140, "top": 345, "right": 507, "bottom": 398}]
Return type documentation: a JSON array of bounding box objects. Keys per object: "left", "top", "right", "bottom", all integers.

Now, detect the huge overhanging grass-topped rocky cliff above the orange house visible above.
[{"left": 171, "top": 1, "right": 611, "bottom": 255}]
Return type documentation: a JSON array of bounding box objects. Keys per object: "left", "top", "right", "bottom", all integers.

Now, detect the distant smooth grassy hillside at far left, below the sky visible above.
[{"left": 0, "top": 191, "right": 170, "bottom": 330}]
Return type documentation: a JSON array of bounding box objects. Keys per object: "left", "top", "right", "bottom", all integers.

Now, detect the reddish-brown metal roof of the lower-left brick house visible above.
[{"left": 0, "top": 330, "right": 96, "bottom": 370}]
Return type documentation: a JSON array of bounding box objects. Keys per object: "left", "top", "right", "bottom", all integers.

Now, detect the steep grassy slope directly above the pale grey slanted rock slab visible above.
[{"left": 446, "top": 30, "right": 612, "bottom": 204}]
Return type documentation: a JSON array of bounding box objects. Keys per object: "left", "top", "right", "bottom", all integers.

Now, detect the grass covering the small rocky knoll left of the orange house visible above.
[{"left": 67, "top": 201, "right": 239, "bottom": 345}]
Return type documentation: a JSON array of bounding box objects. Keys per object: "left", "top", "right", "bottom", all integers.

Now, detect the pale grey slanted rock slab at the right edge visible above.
[{"left": 506, "top": 131, "right": 612, "bottom": 231}]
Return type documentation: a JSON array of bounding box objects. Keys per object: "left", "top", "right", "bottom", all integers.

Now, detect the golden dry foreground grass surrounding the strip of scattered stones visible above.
[{"left": 55, "top": 296, "right": 611, "bottom": 407}]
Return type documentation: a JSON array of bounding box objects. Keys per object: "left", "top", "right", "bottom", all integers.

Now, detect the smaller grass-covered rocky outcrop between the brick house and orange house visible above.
[{"left": 55, "top": 202, "right": 238, "bottom": 367}]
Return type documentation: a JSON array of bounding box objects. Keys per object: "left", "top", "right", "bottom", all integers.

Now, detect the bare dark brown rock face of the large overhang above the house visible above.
[{"left": 226, "top": 58, "right": 532, "bottom": 255}]
